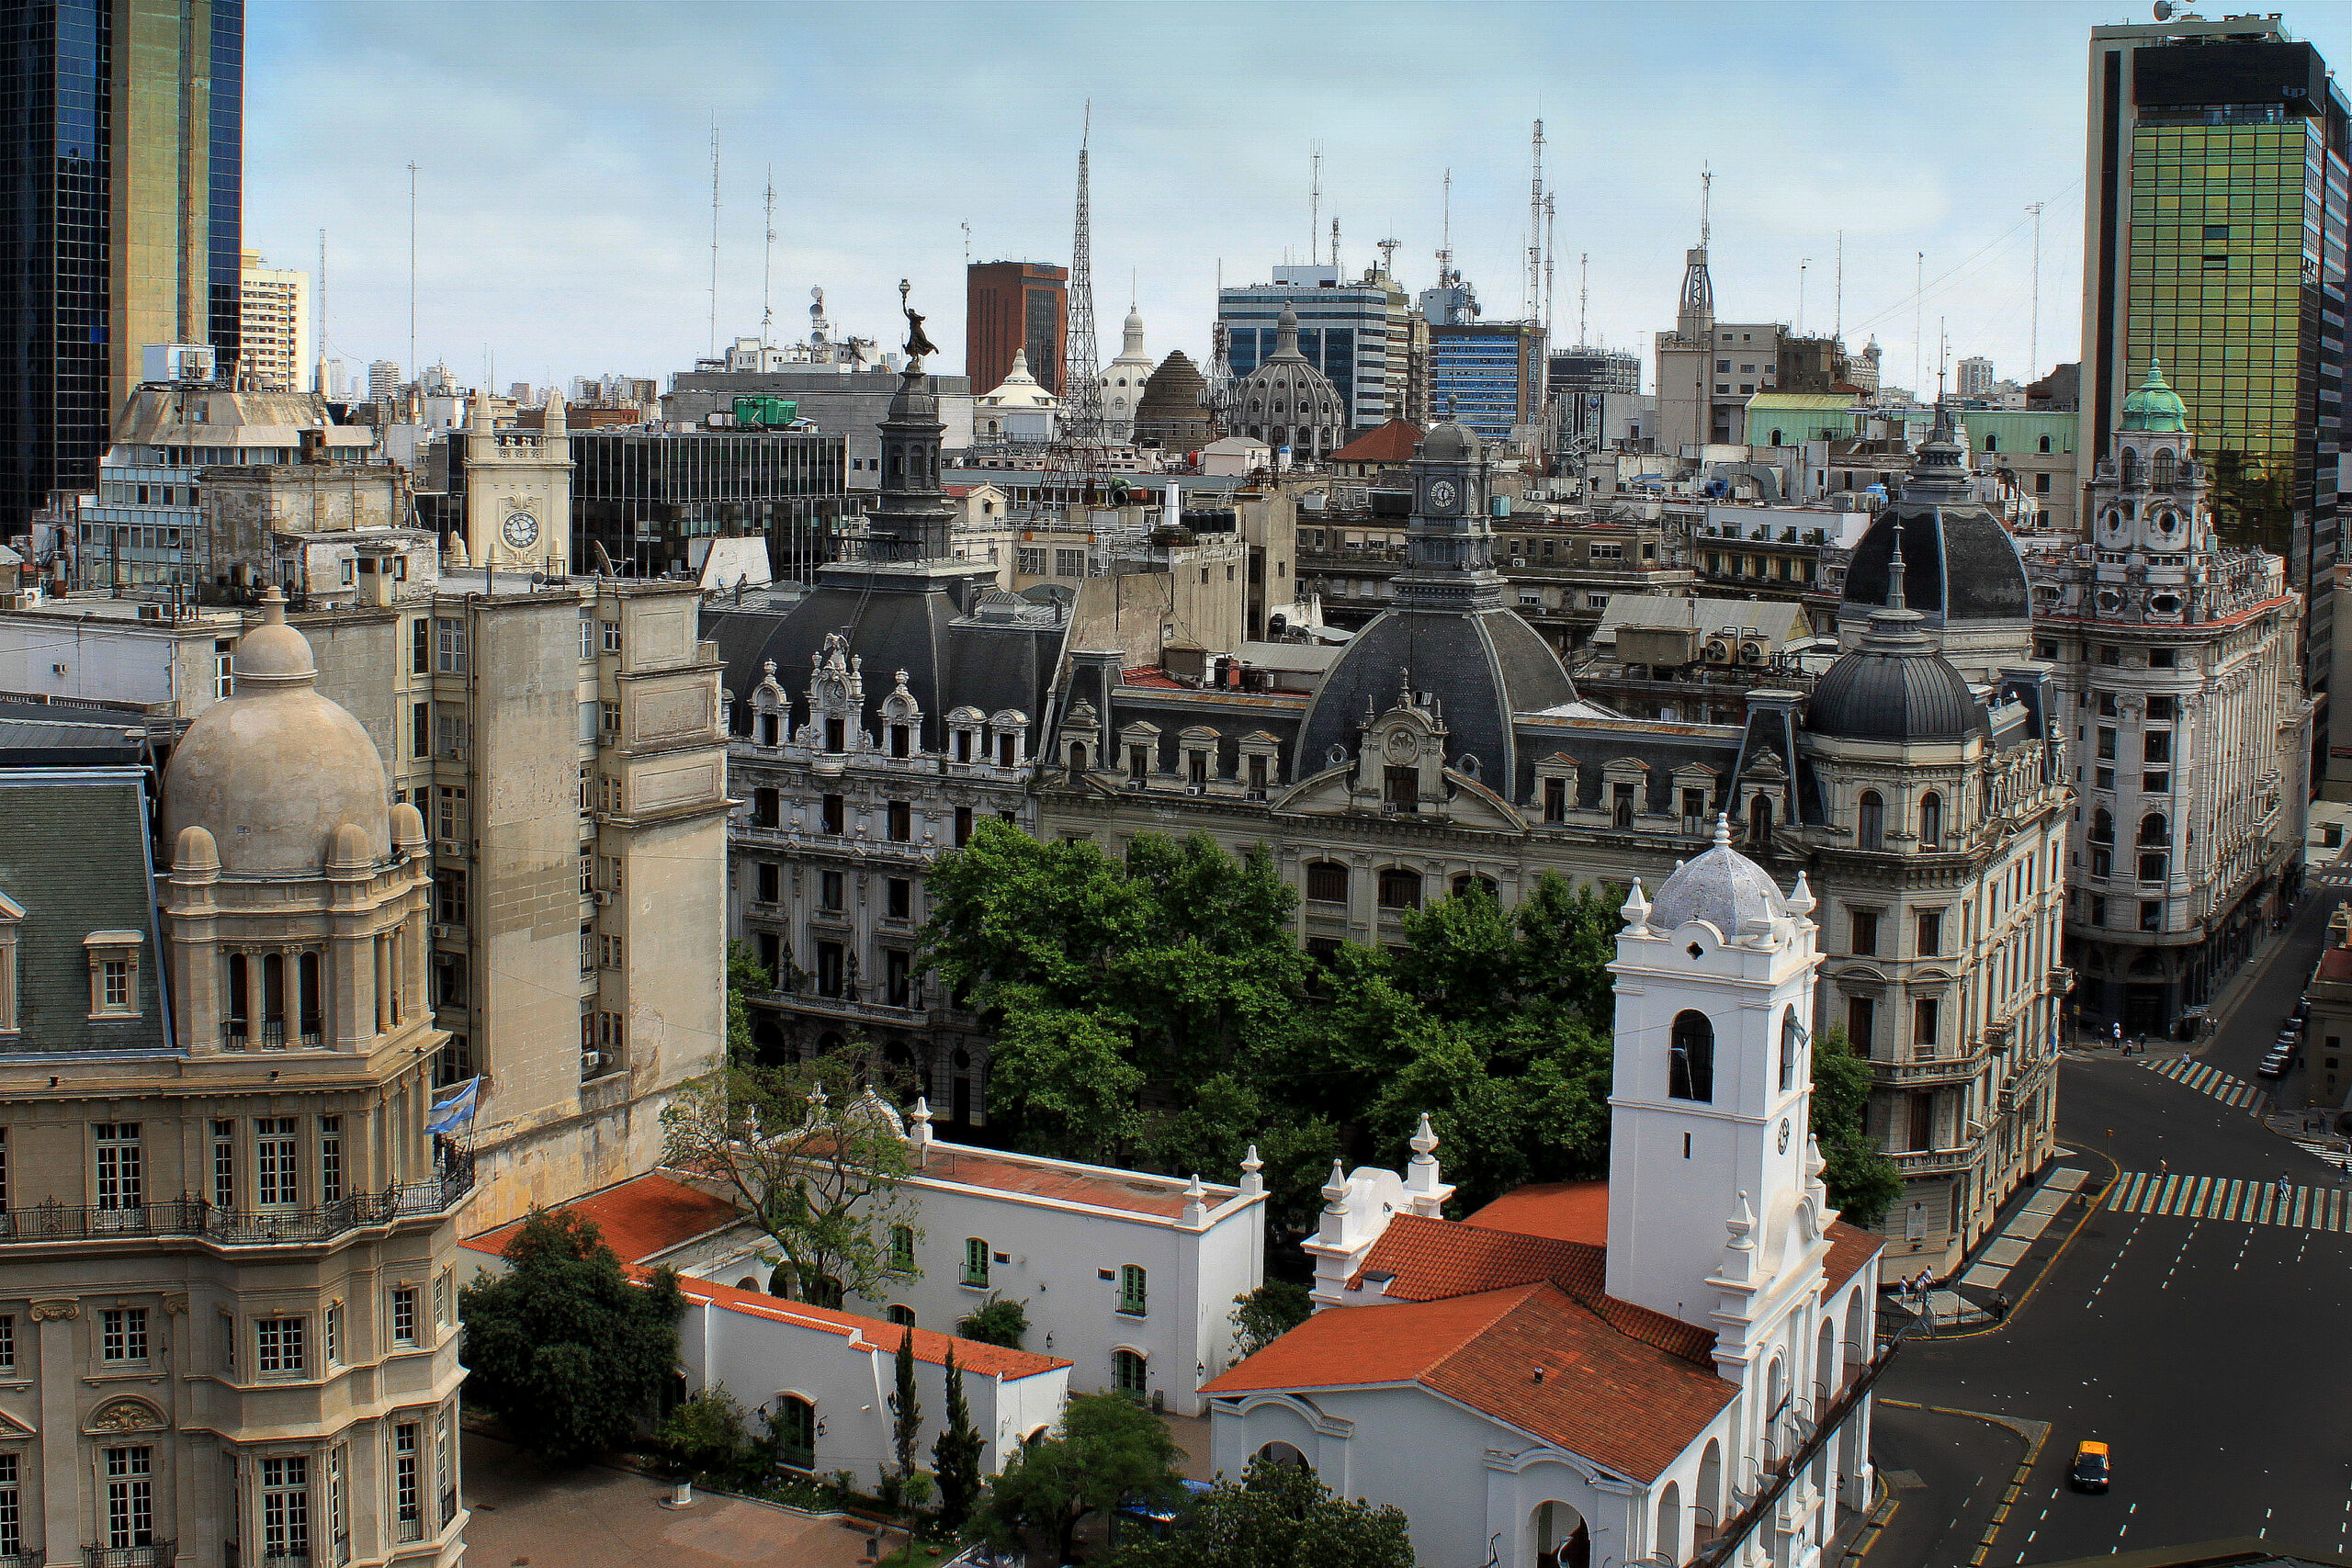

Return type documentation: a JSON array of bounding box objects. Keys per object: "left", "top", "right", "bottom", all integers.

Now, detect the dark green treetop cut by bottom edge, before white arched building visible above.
[{"left": 1105, "top": 1460, "right": 1414, "bottom": 1568}]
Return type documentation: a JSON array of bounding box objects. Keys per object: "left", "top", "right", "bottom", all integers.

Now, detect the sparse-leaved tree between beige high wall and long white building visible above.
[{"left": 661, "top": 1058, "right": 912, "bottom": 1307}]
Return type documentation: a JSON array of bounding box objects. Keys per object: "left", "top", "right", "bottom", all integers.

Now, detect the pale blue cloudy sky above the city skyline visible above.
[{"left": 244, "top": 0, "right": 2352, "bottom": 404}]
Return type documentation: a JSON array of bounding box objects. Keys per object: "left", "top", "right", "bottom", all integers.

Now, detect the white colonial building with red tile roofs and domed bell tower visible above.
[{"left": 1206, "top": 829, "right": 1879, "bottom": 1568}]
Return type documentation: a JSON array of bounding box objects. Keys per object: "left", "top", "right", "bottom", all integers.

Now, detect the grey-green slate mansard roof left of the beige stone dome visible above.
[{"left": 0, "top": 769, "right": 169, "bottom": 1051}]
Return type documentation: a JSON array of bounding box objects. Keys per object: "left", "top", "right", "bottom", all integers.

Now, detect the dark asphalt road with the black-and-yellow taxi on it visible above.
[{"left": 1868, "top": 888, "right": 2352, "bottom": 1568}]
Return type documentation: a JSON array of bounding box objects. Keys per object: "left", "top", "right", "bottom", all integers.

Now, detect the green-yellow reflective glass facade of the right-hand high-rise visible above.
[{"left": 2126, "top": 110, "right": 2343, "bottom": 564}]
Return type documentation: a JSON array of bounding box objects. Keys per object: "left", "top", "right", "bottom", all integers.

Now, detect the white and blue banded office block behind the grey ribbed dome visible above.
[{"left": 1216, "top": 264, "right": 1404, "bottom": 430}]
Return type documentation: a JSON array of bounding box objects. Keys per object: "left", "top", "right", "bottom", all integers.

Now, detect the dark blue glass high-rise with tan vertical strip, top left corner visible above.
[{"left": 0, "top": 0, "right": 244, "bottom": 531}]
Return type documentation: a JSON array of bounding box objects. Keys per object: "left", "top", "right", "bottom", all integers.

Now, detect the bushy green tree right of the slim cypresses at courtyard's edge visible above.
[{"left": 971, "top": 1394, "right": 1183, "bottom": 1563}]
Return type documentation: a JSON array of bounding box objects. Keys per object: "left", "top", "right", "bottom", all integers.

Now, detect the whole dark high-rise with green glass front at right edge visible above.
[{"left": 2075, "top": 17, "right": 2352, "bottom": 790}]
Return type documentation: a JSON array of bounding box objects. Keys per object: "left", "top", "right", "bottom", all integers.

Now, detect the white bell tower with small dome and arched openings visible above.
[{"left": 1609, "top": 818, "right": 1830, "bottom": 1340}]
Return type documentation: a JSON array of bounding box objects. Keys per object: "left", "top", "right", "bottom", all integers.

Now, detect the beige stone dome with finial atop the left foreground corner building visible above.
[{"left": 163, "top": 588, "right": 393, "bottom": 877}]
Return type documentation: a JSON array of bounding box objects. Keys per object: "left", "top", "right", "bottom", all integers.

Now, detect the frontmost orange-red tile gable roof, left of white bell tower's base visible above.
[{"left": 1202, "top": 1283, "right": 1738, "bottom": 1481}]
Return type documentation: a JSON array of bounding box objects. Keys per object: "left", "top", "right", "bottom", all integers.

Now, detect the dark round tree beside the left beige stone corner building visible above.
[{"left": 458, "top": 1211, "right": 684, "bottom": 1460}]
